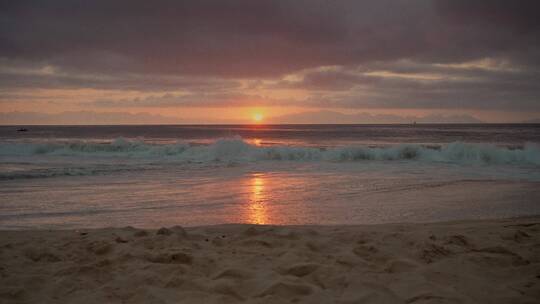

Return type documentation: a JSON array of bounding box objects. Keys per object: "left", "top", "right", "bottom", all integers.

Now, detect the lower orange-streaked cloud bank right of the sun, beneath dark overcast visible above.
[{"left": 273, "top": 60, "right": 540, "bottom": 111}]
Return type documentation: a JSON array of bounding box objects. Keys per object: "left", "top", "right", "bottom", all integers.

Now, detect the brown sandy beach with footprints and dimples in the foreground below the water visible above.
[{"left": 0, "top": 217, "right": 540, "bottom": 303}]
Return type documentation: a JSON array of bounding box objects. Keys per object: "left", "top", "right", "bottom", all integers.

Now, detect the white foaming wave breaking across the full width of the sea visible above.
[{"left": 0, "top": 138, "right": 540, "bottom": 165}]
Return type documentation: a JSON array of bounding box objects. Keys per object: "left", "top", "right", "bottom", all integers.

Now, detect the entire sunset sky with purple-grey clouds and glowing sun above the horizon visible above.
[{"left": 0, "top": 0, "right": 540, "bottom": 124}]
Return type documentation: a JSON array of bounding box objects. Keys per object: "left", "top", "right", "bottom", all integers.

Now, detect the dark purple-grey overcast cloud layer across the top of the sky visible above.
[{"left": 4, "top": 0, "right": 540, "bottom": 76}]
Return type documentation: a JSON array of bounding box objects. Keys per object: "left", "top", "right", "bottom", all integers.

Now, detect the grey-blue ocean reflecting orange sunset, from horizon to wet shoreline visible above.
[{"left": 0, "top": 124, "right": 540, "bottom": 229}]
